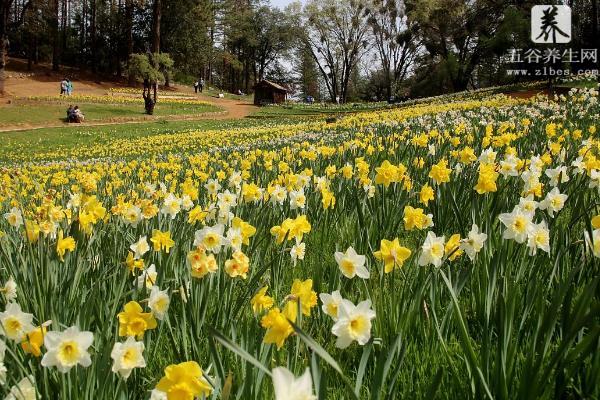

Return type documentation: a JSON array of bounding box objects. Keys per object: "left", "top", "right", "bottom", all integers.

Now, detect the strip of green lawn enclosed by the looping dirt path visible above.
[{"left": 0, "top": 101, "right": 221, "bottom": 127}]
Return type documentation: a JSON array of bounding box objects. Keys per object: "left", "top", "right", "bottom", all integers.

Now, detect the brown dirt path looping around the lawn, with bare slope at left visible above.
[{"left": 0, "top": 59, "right": 256, "bottom": 132}]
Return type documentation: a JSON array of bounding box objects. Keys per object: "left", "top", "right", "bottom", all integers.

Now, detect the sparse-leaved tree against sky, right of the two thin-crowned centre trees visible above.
[{"left": 365, "top": 0, "right": 419, "bottom": 99}]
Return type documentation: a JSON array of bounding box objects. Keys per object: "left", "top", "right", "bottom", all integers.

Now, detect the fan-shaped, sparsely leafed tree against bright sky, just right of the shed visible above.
[{"left": 304, "top": 0, "right": 368, "bottom": 102}]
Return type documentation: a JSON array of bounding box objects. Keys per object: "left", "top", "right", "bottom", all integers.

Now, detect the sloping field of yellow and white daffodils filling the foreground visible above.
[{"left": 0, "top": 89, "right": 600, "bottom": 400}]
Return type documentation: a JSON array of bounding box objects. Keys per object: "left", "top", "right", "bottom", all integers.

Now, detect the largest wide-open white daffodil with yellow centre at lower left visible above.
[{"left": 42, "top": 326, "right": 94, "bottom": 373}]
